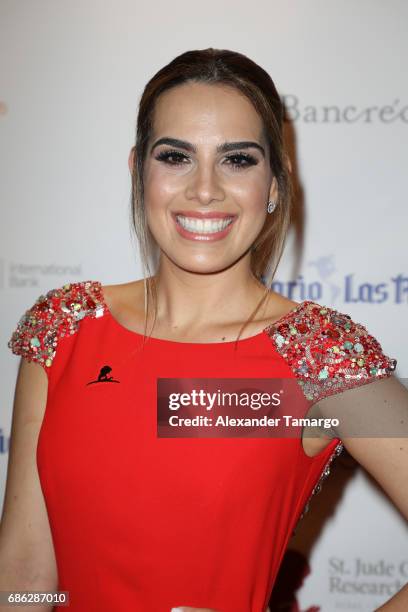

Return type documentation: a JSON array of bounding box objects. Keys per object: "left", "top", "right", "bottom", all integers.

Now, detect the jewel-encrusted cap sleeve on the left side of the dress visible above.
[{"left": 7, "top": 280, "right": 106, "bottom": 374}]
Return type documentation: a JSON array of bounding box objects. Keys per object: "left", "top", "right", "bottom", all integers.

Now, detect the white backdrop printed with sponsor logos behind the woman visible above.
[{"left": 0, "top": 0, "right": 408, "bottom": 612}]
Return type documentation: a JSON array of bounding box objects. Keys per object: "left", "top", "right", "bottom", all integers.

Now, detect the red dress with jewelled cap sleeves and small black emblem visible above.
[{"left": 8, "top": 281, "right": 396, "bottom": 612}]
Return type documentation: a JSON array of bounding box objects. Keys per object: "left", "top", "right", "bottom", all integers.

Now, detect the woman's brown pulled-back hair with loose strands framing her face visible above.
[{"left": 131, "top": 47, "right": 293, "bottom": 350}]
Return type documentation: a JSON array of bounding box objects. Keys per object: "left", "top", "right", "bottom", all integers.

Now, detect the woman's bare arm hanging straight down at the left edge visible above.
[{"left": 0, "top": 358, "right": 58, "bottom": 612}]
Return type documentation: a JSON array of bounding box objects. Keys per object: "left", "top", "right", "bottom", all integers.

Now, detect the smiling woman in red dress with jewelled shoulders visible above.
[{"left": 0, "top": 48, "right": 408, "bottom": 612}]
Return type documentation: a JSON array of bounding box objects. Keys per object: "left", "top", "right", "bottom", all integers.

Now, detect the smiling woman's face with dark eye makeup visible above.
[{"left": 130, "top": 83, "right": 277, "bottom": 273}]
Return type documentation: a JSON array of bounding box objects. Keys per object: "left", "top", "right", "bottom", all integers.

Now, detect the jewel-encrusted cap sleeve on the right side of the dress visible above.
[{"left": 266, "top": 300, "right": 397, "bottom": 402}]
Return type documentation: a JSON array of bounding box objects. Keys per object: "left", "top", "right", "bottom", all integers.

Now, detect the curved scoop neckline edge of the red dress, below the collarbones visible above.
[{"left": 96, "top": 281, "right": 315, "bottom": 347}]
